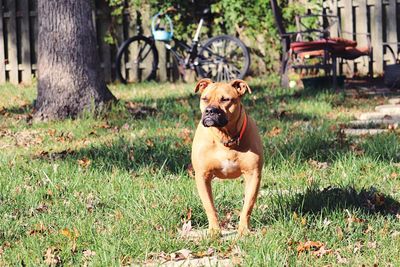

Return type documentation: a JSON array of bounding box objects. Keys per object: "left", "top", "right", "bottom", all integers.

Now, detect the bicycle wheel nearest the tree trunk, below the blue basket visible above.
[{"left": 115, "top": 36, "right": 158, "bottom": 83}]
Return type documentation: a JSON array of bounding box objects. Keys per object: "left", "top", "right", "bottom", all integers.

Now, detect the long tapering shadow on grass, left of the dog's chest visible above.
[{"left": 39, "top": 136, "right": 190, "bottom": 174}]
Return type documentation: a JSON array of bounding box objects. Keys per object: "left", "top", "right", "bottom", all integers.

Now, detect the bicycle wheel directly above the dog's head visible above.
[{"left": 196, "top": 35, "right": 250, "bottom": 81}]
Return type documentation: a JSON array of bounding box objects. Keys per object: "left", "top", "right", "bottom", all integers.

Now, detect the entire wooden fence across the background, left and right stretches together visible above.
[{"left": 0, "top": 0, "right": 400, "bottom": 84}]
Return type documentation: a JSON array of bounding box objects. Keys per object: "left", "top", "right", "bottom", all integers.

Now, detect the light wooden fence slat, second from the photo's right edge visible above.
[{"left": 371, "top": 0, "right": 383, "bottom": 74}]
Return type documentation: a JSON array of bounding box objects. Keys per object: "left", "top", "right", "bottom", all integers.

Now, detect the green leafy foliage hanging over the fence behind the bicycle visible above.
[{"left": 104, "top": 0, "right": 321, "bottom": 74}]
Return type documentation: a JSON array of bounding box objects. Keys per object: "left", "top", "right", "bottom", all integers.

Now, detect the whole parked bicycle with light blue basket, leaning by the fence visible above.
[{"left": 116, "top": 9, "right": 250, "bottom": 83}]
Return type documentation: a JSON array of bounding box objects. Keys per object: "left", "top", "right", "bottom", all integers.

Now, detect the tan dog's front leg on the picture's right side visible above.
[{"left": 238, "top": 170, "right": 261, "bottom": 235}]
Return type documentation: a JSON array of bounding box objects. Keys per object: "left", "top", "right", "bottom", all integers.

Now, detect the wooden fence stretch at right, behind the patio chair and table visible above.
[{"left": 324, "top": 0, "right": 400, "bottom": 75}]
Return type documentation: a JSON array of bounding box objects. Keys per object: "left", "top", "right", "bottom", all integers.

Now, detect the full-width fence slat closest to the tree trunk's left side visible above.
[{"left": 20, "top": 0, "right": 32, "bottom": 83}]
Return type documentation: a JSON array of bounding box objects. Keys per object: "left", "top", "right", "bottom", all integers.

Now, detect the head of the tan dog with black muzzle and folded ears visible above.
[{"left": 194, "top": 79, "right": 251, "bottom": 127}]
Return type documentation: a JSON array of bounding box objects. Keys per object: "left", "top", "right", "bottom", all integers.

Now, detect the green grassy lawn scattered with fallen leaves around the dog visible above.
[{"left": 0, "top": 79, "right": 400, "bottom": 266}]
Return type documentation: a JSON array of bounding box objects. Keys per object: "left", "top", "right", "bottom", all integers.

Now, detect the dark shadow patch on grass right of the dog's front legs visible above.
[{"left": 259, "top": 185, "right": 400, "bottom": 225}]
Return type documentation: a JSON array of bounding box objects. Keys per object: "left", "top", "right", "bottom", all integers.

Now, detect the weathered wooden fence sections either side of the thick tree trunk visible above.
[{"left": 0, "top": 0, "right": 176, "bottom": 84}]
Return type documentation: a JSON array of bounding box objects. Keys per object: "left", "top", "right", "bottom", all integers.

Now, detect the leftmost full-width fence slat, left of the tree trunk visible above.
[{"left": 8, "top": 0, "right": 18, "bottom": 84}]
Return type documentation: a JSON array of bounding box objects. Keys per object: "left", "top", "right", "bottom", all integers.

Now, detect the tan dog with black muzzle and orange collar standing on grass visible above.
[{"left": 192, "top": 79, "right": 263, "bottom": 235}]
